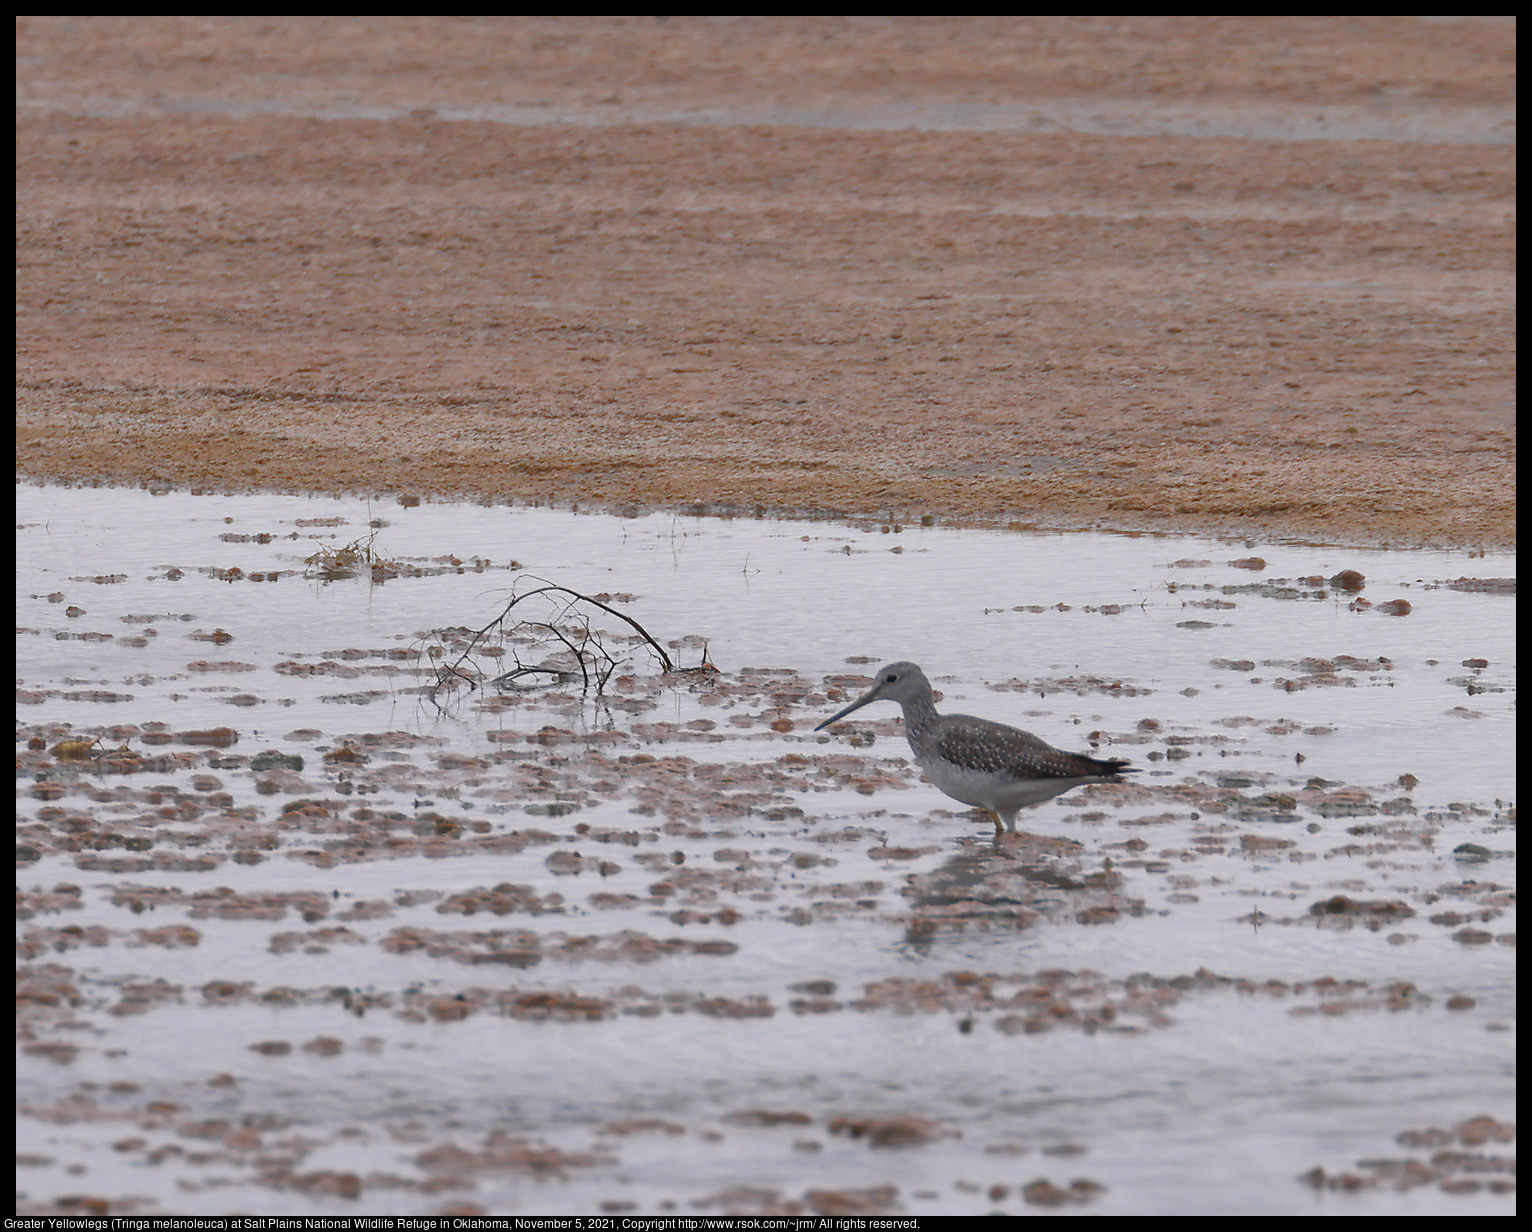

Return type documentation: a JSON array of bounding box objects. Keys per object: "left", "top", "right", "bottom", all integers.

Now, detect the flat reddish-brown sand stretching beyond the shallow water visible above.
[{"left": 17, "top": 17, "right": 1515, "bottom": 547}]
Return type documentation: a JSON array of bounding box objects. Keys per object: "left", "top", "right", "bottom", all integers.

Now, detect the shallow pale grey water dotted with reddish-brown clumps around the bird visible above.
[{"left": 17, "top": 487, "right": 1515, "bottom": 1215}]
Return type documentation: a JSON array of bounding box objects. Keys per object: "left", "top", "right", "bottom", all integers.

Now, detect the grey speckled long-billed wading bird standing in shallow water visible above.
[{"left": 815, "top": 662, "right": 1131, "bottom": 835}]
